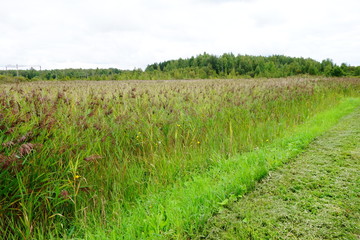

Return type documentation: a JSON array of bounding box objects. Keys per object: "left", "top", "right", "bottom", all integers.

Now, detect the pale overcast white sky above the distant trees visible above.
[{"left": 0, "top": 0, "right": 360, "bottom": 69}]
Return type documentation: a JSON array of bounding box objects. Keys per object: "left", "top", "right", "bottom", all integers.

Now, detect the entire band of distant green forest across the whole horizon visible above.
[{"left": 0, "top": 53, "right": 360, "bottom": 82}]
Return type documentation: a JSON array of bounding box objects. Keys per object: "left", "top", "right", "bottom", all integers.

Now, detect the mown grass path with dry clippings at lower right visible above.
[{"left": 199, "top": 108, "right": 360, "bottom": 239}]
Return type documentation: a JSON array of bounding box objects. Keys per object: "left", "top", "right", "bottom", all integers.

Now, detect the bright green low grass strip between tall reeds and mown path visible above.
[{"left": 83, "top": 98, "right": 360, "bottom": 239}]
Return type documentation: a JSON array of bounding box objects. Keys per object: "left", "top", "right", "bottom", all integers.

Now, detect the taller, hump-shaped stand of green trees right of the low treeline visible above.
[{"left": 145, "top": 53, "right": 360, "bottom": 78}]
